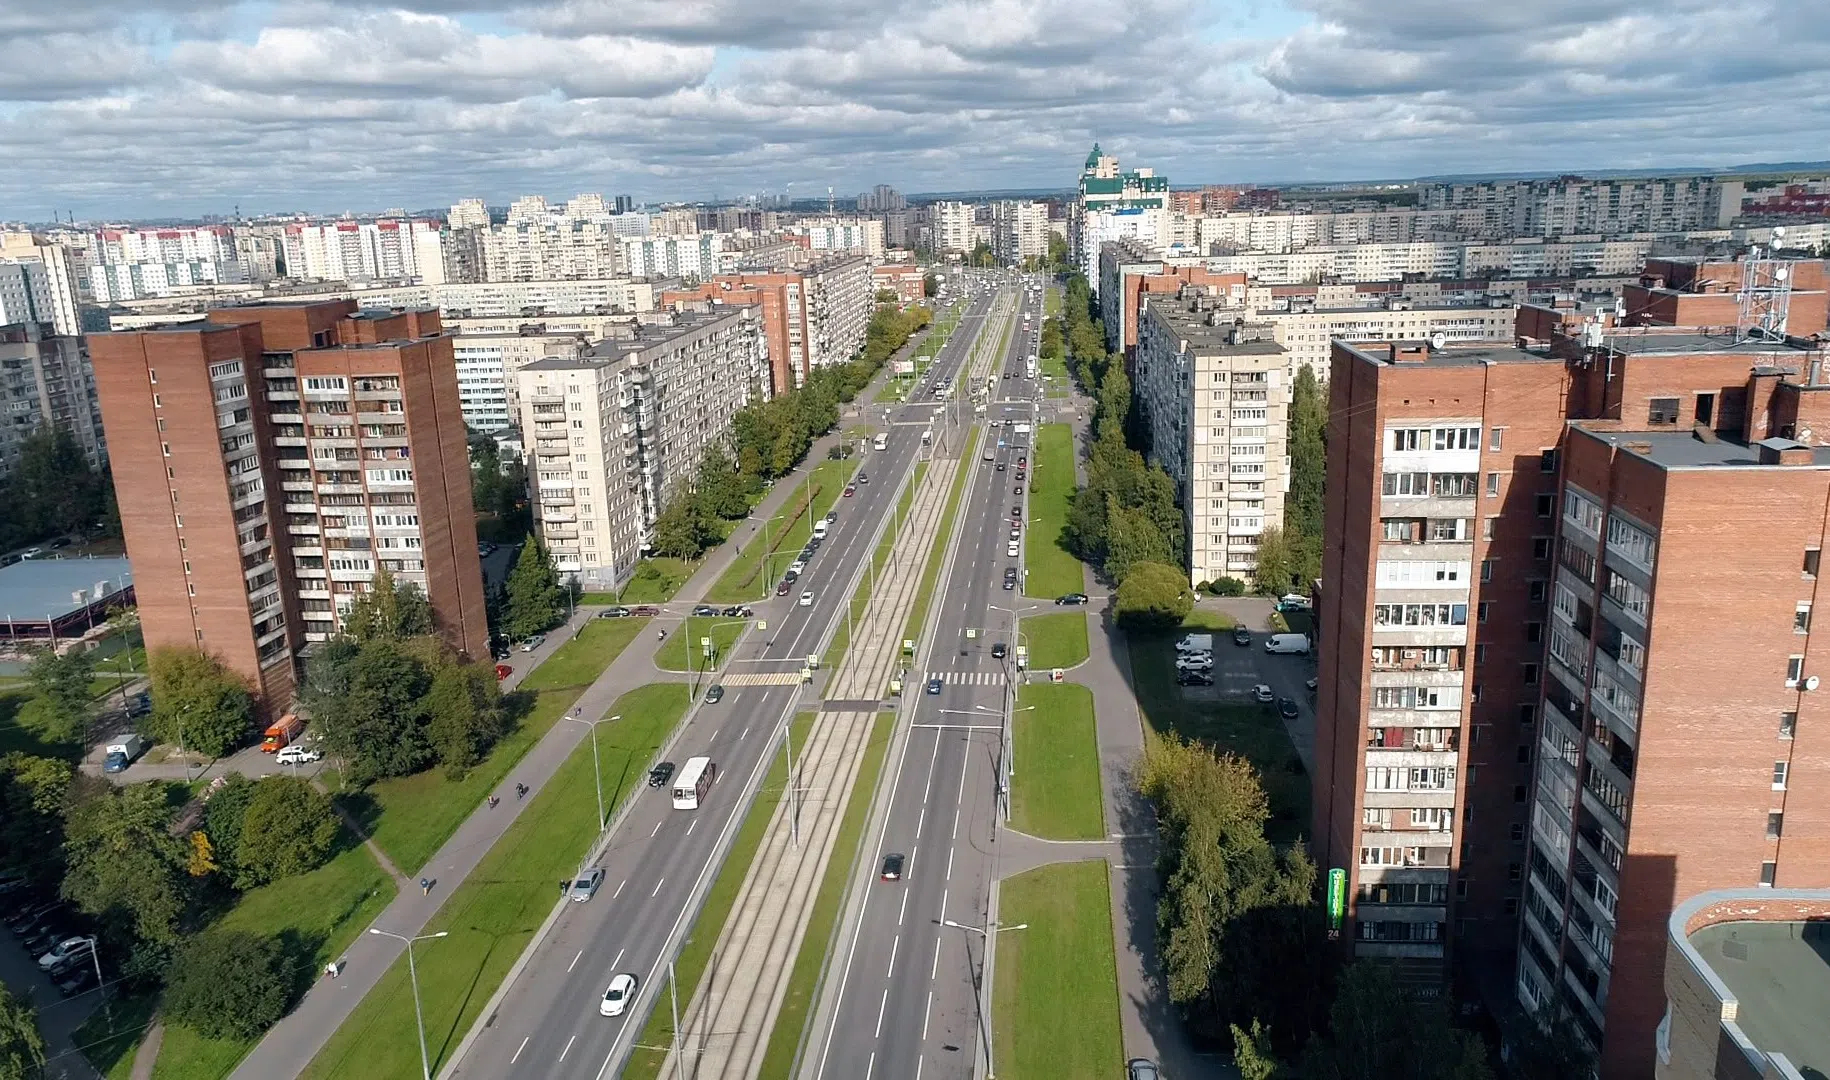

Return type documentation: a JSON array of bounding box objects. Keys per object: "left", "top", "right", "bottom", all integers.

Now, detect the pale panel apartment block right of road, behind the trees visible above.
[{"left": 1133, "top": 291, "right": 1290, "bottom": 584}]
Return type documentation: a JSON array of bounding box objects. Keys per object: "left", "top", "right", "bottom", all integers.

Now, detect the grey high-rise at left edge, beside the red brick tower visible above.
[{"left": 0, "top": 320, "right": 108, "bottom": 476}]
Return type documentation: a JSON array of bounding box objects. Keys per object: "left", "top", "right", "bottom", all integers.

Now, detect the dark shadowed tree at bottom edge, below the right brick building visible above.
[{"left": 1303, "top": 961, "right": 1493, "bottom": 1080}]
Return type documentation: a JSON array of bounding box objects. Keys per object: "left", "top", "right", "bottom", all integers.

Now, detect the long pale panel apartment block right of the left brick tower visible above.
[{"left": 516, "top": 306, "right": 769, "bottom": 588}]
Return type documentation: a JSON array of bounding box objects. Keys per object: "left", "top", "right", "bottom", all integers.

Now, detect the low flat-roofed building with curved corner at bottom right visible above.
[{"left": 1658, "top": 890, "right": 1830, "bottom": 1080}]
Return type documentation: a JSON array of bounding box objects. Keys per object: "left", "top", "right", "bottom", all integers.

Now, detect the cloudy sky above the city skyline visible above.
[{"left": 0, "top": 0, "right": 1830, "bottom": 221}]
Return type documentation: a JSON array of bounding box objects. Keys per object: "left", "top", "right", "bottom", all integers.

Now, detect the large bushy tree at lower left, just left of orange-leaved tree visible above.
[{"left": 62, "top": 782, "right": 188, "bottom": 941}]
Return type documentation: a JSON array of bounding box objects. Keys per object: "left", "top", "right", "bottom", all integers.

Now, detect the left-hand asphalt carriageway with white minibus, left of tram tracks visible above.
[{"left": 450, "top": 287, "right": 990, "bottom": 1078}]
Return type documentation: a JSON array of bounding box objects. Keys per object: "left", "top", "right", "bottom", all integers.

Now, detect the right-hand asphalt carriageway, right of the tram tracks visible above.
[{"left": 803, "top": 272, "right": 1041, "bottom": 1080}]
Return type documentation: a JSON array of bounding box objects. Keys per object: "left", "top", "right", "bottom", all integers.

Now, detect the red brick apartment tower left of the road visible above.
[{"left": 90, "top": 300, "right": 489, "bottom": 710}]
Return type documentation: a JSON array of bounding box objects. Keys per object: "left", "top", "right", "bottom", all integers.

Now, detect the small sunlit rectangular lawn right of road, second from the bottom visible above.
[{"left": 1010, "top": 683, "right": 1105, "bottom": 840}]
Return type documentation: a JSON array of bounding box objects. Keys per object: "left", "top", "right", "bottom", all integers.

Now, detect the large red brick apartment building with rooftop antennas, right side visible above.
[{"left": 1314, "top": 264, "right": 1830, "bottom": 1080}]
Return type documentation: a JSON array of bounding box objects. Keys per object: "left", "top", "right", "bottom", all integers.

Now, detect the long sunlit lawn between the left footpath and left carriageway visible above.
[{"left": 302, "top": 683, "right": 686, "bottom": 1080}]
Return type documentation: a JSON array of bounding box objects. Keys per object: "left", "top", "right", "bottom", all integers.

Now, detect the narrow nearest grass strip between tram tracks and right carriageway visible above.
[{"left": 758, "top": 712, "right": 897, "bottom": 1080}]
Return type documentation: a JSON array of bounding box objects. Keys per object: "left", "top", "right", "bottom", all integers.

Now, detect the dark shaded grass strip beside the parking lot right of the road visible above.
[{"left": 1125, "top": 626, "right": 1308, "bottom": 844}]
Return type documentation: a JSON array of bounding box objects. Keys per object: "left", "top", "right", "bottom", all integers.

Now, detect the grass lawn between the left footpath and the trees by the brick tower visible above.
[{"left": 337, "top": 619, "right": 648, "bottom": 880}]
